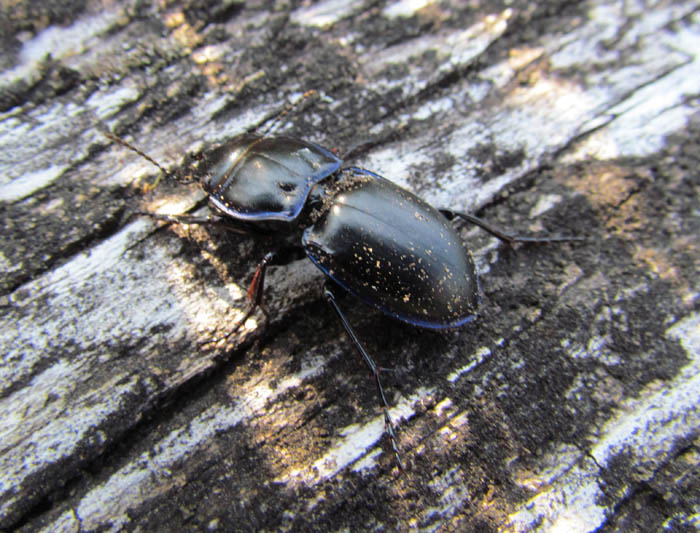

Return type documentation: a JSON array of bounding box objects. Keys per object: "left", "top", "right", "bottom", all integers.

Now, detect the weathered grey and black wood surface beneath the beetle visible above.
[{"left": 0, "top": 0, "right": 700, "bottom": 531}]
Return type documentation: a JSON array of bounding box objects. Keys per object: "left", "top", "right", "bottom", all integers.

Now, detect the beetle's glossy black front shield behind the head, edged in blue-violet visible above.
[{"left": 199, "top": 134, "right": 341, "bottom": 221}]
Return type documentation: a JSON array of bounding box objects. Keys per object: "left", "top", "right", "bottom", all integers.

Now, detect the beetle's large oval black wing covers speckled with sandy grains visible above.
[{"left": 302, "top": 167, "right": 479, "bottom": 329}]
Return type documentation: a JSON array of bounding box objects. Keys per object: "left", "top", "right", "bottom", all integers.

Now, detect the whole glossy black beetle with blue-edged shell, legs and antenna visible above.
[{"left": 107, "top": 129, "right": 577, "bottom": 468}]
